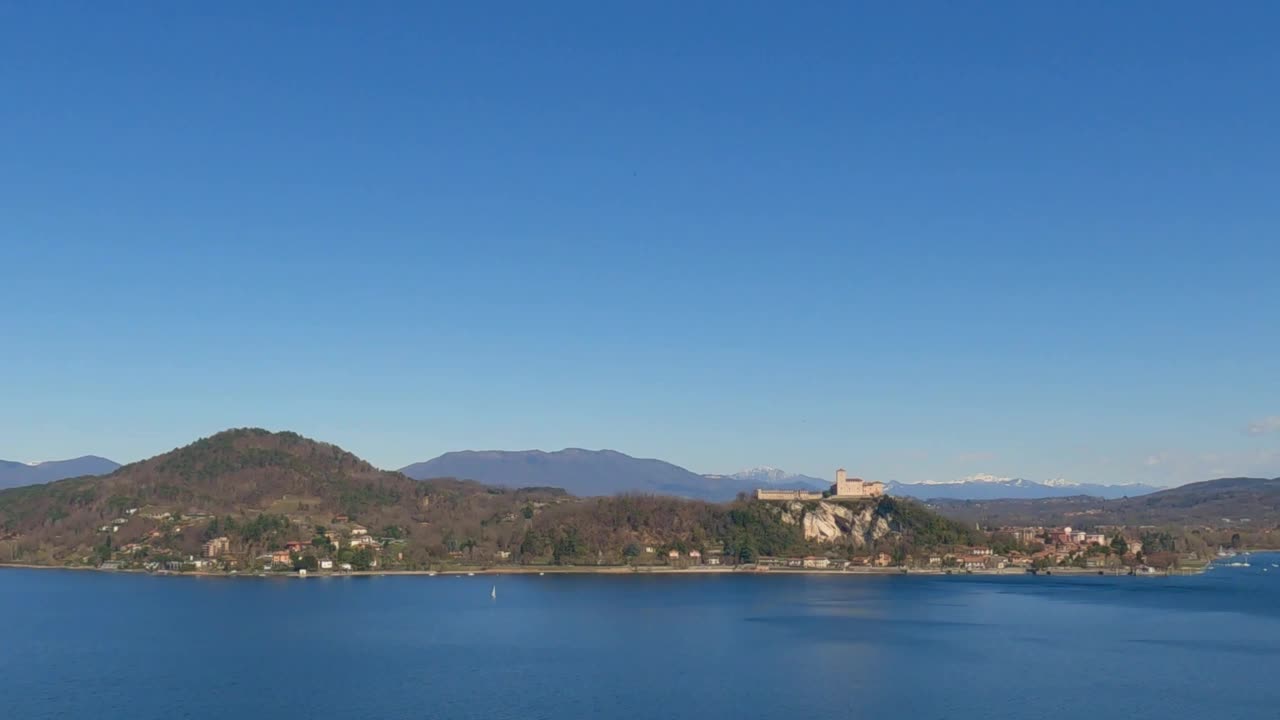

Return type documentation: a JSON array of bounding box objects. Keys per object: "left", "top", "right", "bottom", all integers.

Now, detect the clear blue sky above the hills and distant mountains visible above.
[{"left": 0, "top": 3, "right": 1280, "bottom": 484}]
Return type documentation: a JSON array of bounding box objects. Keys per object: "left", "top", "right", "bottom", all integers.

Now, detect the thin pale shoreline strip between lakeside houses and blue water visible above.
[{"left": 0, "top": 562, "right": 1213, "bottom": 580}]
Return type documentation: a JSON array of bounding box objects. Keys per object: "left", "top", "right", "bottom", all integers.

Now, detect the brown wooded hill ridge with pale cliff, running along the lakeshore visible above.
[{"left": 0, "top": 429, "right": 974, "bottom": 569}]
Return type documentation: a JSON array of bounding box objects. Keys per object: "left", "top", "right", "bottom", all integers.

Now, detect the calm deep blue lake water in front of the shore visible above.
[{"left": 0, "top": 556, "right": 1280, "bottom": 720}]
